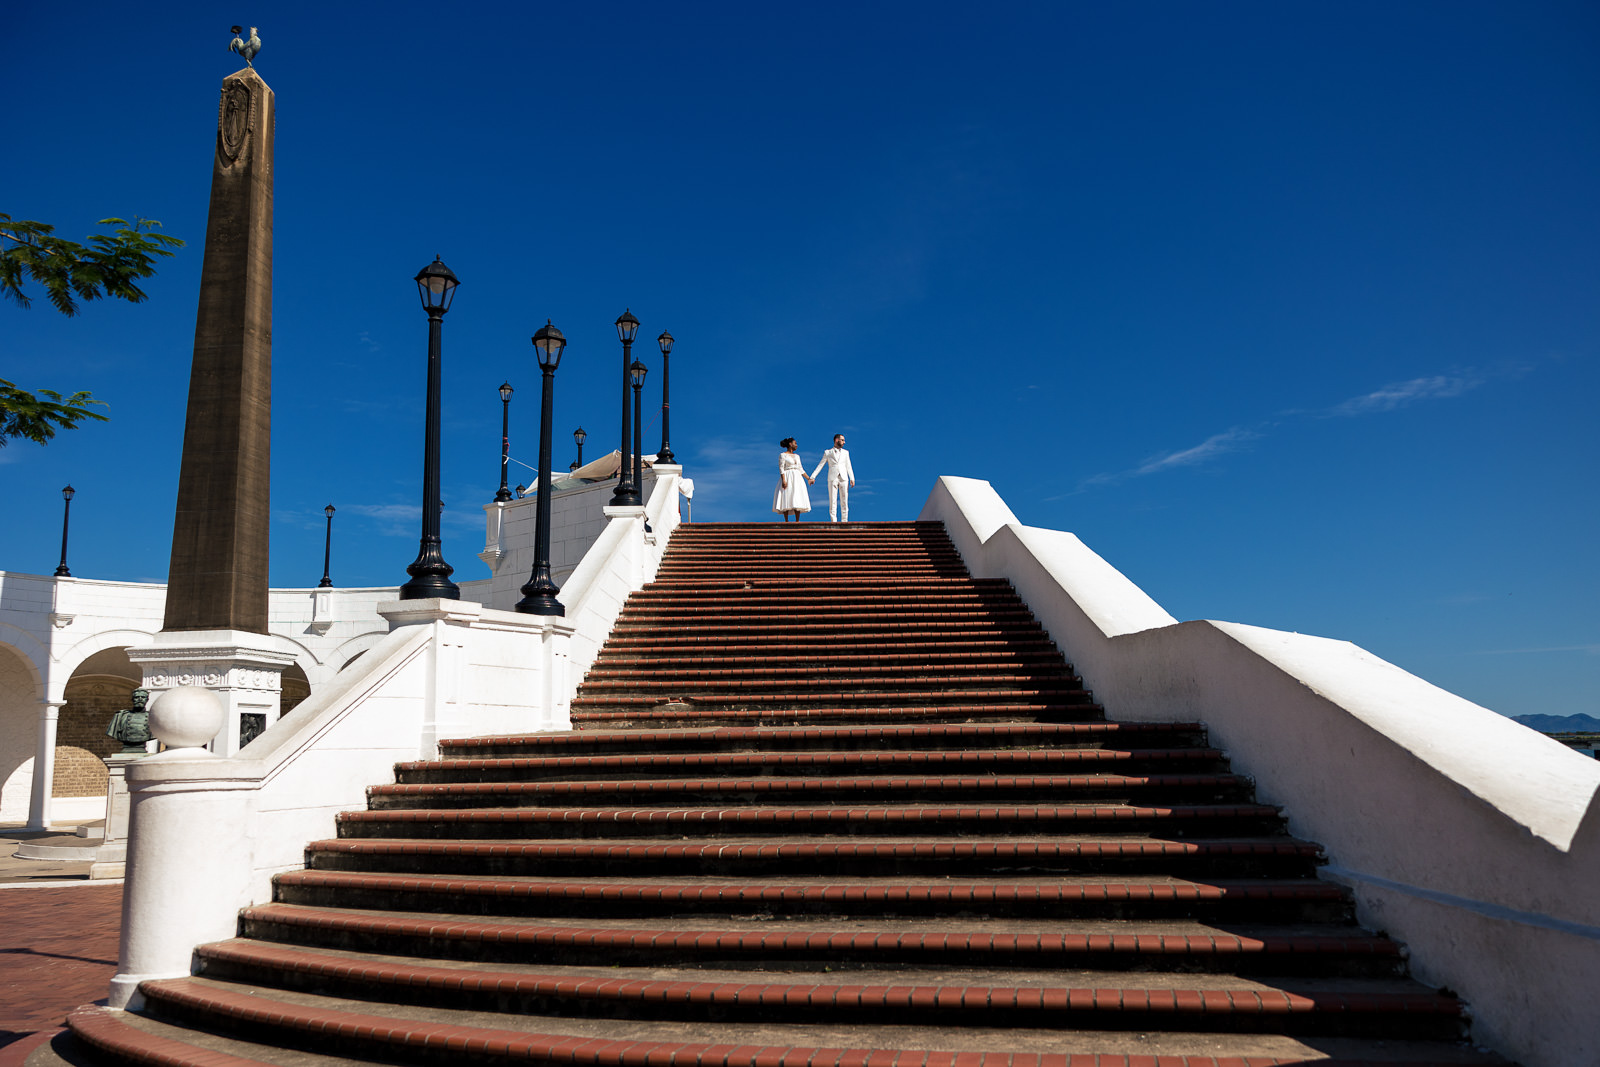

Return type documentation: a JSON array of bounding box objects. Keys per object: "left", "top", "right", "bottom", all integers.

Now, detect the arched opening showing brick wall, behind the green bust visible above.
[{"left": 50, "top": 648, "right": 142, "bottom": 819}]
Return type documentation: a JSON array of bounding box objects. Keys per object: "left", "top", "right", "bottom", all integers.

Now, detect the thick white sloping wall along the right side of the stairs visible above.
[{"left": 922, "top": 477, "right": 1600, "bottom": 1067}]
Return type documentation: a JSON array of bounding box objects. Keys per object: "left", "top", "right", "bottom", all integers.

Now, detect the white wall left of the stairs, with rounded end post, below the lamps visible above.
[{"left": 109, "top": 467, "right": 678, "bottom": 1008}]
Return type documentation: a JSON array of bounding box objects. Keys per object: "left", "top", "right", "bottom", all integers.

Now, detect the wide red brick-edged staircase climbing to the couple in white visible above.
[{"left": 70, "top": 523, "right": 1504, "bottom": 1067}]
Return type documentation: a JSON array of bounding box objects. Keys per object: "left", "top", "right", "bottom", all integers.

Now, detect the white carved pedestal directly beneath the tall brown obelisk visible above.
[{"left": 128, "top": 630, "right": 294, "bottom": 757}]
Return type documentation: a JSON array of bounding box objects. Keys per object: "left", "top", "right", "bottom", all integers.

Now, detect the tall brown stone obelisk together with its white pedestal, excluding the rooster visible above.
[{"left": 130, "top": 67, "right": 291, "bottom": 755}]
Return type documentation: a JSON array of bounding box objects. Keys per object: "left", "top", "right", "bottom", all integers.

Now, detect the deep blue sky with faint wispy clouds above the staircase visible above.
[{"left": 0, "top": 2, "right": 1600, "bottom": 713}]
